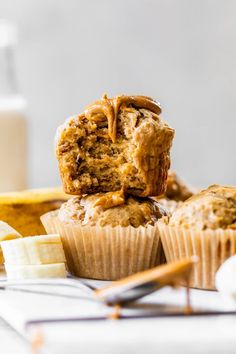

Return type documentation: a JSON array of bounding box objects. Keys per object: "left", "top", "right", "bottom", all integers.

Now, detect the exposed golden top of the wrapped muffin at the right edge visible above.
[{"left": 169, "top": 185, "right": 236, "bottom": 230}]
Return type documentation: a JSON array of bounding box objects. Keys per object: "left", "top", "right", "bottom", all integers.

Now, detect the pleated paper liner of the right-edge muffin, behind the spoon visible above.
[{"left": 157, "top": 220, "right": 236, "bottom": 290}]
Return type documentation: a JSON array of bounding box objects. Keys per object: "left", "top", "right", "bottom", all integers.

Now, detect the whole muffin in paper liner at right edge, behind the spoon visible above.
[{"left": 158, "top": 185, "right": 236, "bottom": 289}]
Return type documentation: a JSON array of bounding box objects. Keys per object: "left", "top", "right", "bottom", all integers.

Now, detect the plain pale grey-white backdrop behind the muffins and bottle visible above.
[{"left": 0, "top": 0, "right": 236, "bottom": 186}]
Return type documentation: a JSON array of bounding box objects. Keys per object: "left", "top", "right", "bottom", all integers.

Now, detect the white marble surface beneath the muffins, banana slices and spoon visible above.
[{"left": 0, "top": 280, "right": 236, "bottom": 354}]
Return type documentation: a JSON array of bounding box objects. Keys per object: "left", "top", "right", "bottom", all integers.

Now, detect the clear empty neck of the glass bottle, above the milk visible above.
[{"left": 0, "top": 46, "right": 17, "bottom": 97}]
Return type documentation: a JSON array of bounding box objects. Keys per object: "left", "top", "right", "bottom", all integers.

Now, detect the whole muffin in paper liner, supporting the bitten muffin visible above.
[{"left": 41, "top": 192, "right": 168, "bottom": 280}]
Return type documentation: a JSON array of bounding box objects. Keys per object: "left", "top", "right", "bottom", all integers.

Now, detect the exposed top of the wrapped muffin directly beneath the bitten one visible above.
[{"left": 58, "top": 192, "right": 167, "bottom": 227}]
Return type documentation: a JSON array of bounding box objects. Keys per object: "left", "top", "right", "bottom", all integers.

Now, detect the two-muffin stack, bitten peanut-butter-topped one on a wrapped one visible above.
[{"left": 42, "top": 95, "right": 174, "bottom": 280}]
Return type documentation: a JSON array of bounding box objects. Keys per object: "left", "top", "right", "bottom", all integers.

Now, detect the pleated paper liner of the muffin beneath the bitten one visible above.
[{"left": 41, "top": 211, "right": 164, "bottom": 280}]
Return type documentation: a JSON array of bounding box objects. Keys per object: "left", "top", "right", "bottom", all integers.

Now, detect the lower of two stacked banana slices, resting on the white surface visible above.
[{"left": 5, "top": 263, "right": 66, "bottom": 280}]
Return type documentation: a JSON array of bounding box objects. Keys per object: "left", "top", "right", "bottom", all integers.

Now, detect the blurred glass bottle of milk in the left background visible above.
[{"left": 0, "top": 20, "right": 27, "bottom": 192}]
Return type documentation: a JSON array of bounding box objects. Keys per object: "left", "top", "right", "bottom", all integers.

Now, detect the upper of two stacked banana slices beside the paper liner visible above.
[{"left": 1, "top": 234, "right": 66, "bottom": 265}]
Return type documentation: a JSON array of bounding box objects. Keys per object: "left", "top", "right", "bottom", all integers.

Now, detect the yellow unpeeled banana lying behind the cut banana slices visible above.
[{"left": 0, "top": 188, "right": 68, "bottom": 236}]
